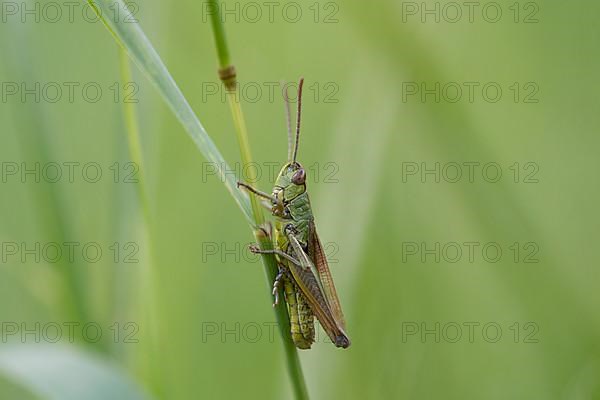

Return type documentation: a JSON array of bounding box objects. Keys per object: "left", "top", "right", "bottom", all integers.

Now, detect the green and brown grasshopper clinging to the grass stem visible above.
[{"left": 238, "top": 79, "right": 350, "bottom": 349}]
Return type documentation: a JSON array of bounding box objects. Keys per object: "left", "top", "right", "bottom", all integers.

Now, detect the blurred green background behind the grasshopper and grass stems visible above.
[{"left": 0, "top": 0, "right": 600, "bottom": 399}]
